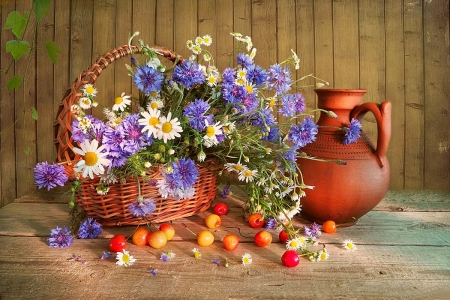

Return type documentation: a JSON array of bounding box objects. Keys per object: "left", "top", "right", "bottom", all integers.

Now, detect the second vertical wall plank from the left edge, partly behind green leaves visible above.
[{"left": 15, "top": 1, "right": 37, "bottom": 197}]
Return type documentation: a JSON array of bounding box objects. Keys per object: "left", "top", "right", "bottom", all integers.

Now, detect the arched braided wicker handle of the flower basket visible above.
[{"left": 53, "top": 45, "right": 184, "bottom": 176}]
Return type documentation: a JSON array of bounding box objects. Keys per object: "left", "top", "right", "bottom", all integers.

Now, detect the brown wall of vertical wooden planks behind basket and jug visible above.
[{"left": 0, "top": 0, "right": 450, "bottom": 206}]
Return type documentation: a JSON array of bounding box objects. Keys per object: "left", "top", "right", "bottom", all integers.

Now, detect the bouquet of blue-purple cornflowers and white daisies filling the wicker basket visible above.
[{"left": 35, "top": 33, "right": 360, "bottom": 227}]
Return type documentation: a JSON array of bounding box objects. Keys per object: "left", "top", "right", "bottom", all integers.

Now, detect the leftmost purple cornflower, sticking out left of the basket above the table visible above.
[{"left": 33, "top": 162, "right": 69, "bottom": 190}]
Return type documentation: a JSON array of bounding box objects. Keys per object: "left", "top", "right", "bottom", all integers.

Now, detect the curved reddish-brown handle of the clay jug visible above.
[{"left": 350, "top": 101, "right": 392, "bottom": 168}]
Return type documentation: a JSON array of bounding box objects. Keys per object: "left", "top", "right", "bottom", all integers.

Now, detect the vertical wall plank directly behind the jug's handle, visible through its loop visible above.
[{"left": 359, "top": 0, "right": 386, "bottom": 142}]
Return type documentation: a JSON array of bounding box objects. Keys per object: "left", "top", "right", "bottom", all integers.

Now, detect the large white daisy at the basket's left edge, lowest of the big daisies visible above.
[{"left": 72, "top": 140, "right": 110, "bottom": 179}]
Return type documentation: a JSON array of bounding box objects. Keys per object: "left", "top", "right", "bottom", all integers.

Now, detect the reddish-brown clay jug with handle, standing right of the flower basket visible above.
[{"left": 297, "top": 89, "right": 391, "bottom": 226}]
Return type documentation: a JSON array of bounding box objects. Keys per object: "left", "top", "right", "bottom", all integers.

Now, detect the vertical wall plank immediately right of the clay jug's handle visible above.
[{"left": 385, "top": 0, "right": 405, "bottom": 190}]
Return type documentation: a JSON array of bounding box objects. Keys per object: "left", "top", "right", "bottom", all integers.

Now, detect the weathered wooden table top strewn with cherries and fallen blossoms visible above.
[{"left": 0, "top": 191, "right": 450, "bottom": 300}]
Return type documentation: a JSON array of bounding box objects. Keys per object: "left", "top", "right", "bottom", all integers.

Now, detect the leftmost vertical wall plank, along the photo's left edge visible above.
[{"left": 0, "top": 1, "right": 17, "bottom": 207}]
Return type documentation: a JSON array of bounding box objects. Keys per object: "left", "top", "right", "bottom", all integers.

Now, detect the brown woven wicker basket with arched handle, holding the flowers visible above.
[{"left": 54, "top": 46, "right": 217, "bottom": 226}]
